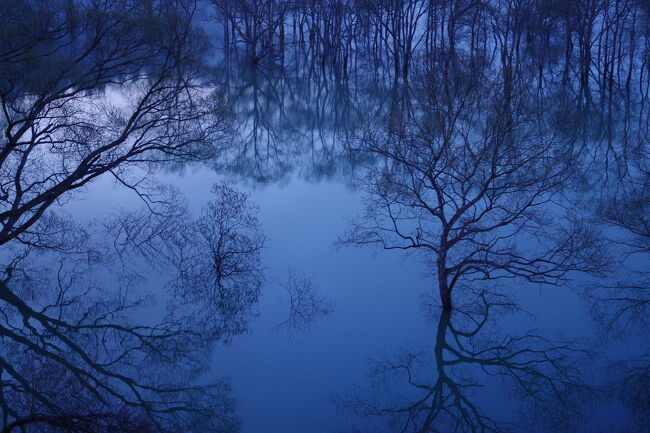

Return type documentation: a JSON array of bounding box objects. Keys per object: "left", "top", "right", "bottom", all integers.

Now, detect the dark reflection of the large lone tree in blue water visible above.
[{"left": 337, "top": 289, "right": 597, "bottom": 432}]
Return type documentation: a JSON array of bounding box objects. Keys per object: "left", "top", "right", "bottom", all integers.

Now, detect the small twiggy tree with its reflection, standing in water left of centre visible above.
[{"left": 172, "top": 184, "right": 265, "bottom": 335}]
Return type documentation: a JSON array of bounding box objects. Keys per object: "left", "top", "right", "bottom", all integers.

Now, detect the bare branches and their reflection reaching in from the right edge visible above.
[{"left": 582, "top": 153, "right": 650, "bottom": 432}]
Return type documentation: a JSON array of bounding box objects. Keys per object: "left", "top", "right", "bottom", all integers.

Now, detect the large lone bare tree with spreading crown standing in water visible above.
[{"left": 341, "top": 70, "right": 603, "bottom": 310}]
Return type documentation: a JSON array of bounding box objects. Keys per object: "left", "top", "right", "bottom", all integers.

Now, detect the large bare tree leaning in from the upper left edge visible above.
[{"left": 0, "top": 0, "right": 229, "bottom": 250}]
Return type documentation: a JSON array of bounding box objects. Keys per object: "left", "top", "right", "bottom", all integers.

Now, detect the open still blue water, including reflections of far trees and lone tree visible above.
[{"left": 137, "top": 58, "right": 647, "bottom": 433}]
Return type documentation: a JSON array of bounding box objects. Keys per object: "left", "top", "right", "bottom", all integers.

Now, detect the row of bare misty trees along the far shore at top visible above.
[{"left": 212, "top": 0, "right": 648, "bottom": 95}]
